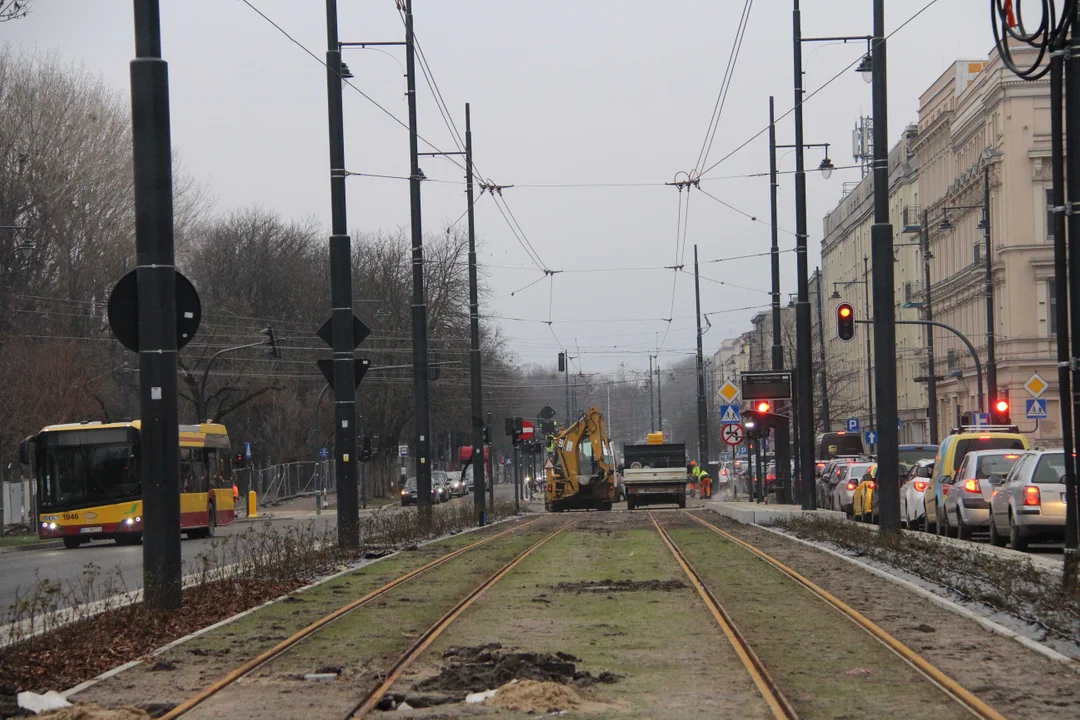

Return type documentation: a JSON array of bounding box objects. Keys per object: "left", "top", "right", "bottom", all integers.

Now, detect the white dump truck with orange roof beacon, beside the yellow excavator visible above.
[{"left": 622, "top": 433, "right": 686, "bottom": 510}]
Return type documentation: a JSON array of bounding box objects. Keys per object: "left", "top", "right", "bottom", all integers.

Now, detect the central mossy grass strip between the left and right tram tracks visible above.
[{"left": 395, "top": 514, "right": 768, "bottom": 718}]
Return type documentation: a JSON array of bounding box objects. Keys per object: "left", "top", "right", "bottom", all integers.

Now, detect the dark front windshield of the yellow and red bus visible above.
[{"left": 37, "top": 429, "right": 141, "bottom": 511}]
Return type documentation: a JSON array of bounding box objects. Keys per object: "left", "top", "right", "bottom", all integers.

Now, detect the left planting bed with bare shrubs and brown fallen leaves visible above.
[{"left": 0, "top": 503, "right": 513, "bottom": 691}]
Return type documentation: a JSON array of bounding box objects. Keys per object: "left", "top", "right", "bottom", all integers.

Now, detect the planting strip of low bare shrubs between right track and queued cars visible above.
[{"left": 777, "top": 517, "right": 1080, "bottom": 642}]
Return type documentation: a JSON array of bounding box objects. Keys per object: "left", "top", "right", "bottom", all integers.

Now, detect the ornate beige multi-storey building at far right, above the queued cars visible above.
[{"left": 913, "top": 51, "right": 1061, "bottom": 441}]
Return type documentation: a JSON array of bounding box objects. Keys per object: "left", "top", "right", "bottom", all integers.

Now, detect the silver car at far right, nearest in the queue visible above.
[{"left": 990, "top": 450, "right": 1065, "bottom": 551}]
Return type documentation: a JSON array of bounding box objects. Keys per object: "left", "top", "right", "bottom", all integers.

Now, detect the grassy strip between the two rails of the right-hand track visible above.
[{"left": 669, "top": 520, "right": 968, "bottom": 720}]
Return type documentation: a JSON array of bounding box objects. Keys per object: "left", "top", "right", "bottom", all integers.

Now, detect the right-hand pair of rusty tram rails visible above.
[{"left": 682, "top": 511, "right": 1005, "bottom": 720}]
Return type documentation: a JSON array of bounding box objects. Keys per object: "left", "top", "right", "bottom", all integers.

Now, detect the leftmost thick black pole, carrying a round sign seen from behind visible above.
[{"left": 131, "top": 0, "right": 183, "bottom": 610}]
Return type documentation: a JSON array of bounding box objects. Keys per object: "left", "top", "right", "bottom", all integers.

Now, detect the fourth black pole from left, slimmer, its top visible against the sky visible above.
[{"left": 465, "top": 103, "right": 487, "bottom": 527}]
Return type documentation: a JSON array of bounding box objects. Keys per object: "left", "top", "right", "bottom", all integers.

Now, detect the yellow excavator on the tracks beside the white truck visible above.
[{"left": 544, "top": 407, "right": 615, "bottom": 513}]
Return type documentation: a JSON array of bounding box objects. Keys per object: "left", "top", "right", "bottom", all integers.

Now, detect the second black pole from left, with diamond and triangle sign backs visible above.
[{"left": 326, "top": 0, "right": 360, "bottom": 548}]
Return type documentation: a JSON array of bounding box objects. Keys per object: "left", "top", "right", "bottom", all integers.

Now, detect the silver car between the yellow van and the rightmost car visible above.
[{"left": 937, "top": 450, "right": 1020, "bottom": 540}]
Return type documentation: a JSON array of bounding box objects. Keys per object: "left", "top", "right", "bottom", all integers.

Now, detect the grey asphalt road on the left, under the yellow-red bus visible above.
[{"left": 0, "top": 485, "right": 522, "bottom": 624}]
